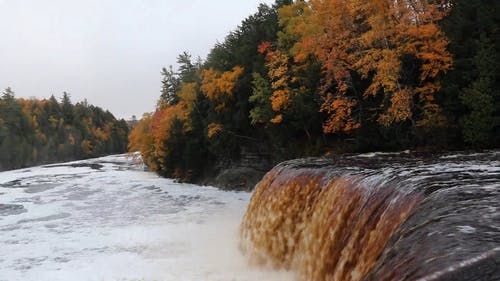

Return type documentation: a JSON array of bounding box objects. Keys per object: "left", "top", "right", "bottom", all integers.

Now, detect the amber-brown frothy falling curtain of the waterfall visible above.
[{"left": 241, "top": 169, "right": 422, "bottom": 281}]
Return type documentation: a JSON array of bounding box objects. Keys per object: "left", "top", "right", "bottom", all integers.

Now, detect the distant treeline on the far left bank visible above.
[{"left": 0, "top": 88, "right": 128, "bottom": 170}]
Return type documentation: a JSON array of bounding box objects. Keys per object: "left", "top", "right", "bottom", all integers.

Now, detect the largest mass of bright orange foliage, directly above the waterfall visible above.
[{"left": 280, "top": 0, "right": 452, "bottom": 132}]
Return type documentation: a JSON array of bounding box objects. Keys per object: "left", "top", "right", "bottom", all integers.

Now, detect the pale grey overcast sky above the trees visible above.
[{"left": 0, "top": 0, "right": 274, "bottom": 119}]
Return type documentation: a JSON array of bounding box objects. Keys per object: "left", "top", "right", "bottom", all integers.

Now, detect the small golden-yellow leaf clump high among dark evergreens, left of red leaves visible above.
[{"left": 200, "top": 66, "right": 244, "bottom": 111}]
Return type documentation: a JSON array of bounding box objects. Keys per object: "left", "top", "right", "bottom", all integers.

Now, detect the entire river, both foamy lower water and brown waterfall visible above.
[{"left": 0, "top": 151, "right": 500, "bottom": 281}]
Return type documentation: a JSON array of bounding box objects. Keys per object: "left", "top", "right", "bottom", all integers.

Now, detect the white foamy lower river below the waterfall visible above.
[{"left": 0, "top": 155, "right": 294, "bottom": 281}]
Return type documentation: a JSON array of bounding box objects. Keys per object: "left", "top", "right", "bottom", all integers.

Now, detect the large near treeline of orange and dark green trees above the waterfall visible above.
[{"left": 129, "top": 0, "right": 500, "bottom": 179}]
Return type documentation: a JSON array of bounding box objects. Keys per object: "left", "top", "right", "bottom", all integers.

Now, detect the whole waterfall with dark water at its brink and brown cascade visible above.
[{"left": 241, "top": 152, "right": 500, "bottom": 280}]
